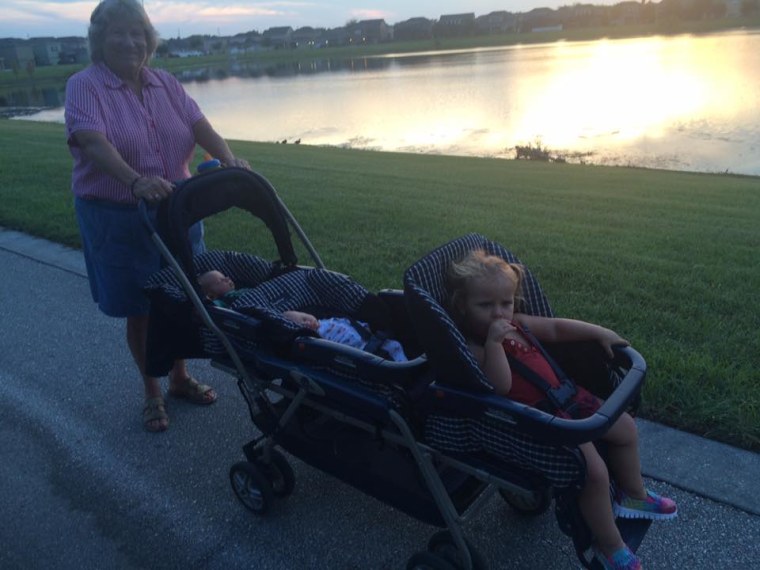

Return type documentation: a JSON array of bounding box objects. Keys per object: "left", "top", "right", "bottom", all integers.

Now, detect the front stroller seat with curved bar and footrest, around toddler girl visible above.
[{"left": 404, "top": 233, "right": 649, "bottom": 568}]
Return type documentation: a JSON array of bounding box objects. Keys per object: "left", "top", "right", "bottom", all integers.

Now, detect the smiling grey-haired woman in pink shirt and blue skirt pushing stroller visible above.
[{"left": 65, "top": 0, "right": 248, "bottom": 432}]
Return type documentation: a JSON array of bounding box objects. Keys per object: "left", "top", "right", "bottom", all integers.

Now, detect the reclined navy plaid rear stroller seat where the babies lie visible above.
[{"left": 145, "top": 251, "right": 426, "bottom": 395}]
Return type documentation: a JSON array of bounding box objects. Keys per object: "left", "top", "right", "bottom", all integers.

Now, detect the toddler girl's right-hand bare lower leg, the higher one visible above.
[{"left": 601, "top": 413, "right": 647, "bottom": 499}]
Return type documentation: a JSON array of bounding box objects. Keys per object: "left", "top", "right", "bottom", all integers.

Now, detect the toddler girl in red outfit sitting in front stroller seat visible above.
[{"left": 447, "top": 250, "right": 677, "bottom": 570}]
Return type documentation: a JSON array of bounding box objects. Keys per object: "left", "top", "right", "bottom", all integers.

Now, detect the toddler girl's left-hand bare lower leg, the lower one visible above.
[{"left": 578, "top": 443, "right": 625, "bottom": 556}]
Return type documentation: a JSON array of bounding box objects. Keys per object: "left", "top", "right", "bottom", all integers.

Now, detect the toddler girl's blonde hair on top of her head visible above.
[{"left": 446, "top": 249, "right": 523, "bottom": 327}]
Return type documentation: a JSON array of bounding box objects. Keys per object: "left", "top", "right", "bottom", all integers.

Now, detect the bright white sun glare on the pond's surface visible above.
[{"left": 512, "top": 39, "right": 736, "bottom": 150}]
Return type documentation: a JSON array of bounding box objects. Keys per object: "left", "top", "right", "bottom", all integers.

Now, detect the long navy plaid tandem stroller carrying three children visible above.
[{"left": 140, "top": 168, "right": 649, "bottom": 570}]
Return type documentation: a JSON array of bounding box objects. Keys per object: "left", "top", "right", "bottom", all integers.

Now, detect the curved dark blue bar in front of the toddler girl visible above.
[{"left": 430, "top": 346, "right": 646, "bottom": 445}]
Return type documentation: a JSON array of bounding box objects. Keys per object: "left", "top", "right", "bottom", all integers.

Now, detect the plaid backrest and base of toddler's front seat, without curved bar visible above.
[{"left": 404, "top": 234, "right": 585, "bottom": 489}]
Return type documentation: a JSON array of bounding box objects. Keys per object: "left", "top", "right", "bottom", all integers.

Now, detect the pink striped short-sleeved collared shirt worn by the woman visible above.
[{"left": 65, "top": 63, "right": 203, "bottom": 204}]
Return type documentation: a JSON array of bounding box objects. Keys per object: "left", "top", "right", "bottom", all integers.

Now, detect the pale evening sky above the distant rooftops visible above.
[{"left": 0, "top": 0, "right": 615, "bottom": 39}]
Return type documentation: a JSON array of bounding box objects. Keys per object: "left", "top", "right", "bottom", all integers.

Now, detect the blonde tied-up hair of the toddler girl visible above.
[{"left": 446, "top": 249, "right": 524, "bottom": 324}]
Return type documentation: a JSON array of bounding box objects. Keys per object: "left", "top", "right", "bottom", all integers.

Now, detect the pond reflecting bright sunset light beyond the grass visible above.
[{"left": 7, "top": 31, "right": 760, "bottom": 175}]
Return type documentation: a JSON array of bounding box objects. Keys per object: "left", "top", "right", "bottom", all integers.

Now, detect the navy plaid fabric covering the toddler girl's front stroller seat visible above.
[{"left": 404, "top": 234, "right": 585, "bottom": 488}]
